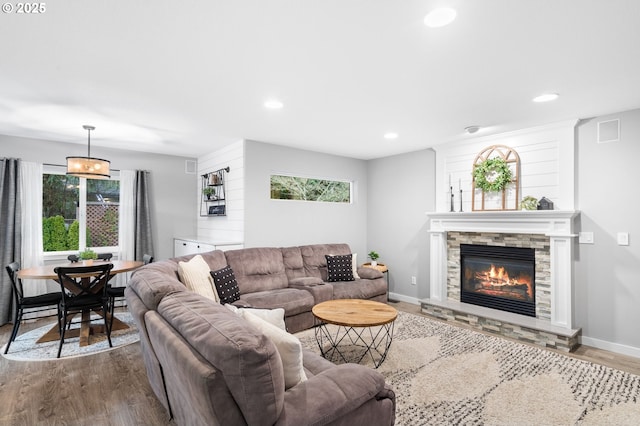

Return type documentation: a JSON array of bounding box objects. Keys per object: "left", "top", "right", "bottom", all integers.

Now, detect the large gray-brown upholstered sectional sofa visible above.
[{"left": 125, "top": 244, "right": 395, "bottom": 425}]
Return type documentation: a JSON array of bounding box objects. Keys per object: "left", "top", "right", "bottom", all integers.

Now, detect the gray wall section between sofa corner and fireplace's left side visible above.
[{"left": 367, "top": 149, "right": 436, "bottom": 303}]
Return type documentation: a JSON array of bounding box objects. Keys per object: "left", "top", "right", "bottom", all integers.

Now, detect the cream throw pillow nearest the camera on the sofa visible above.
[{"left": 243, "top": 312, "right": 307, "bottom": 390}]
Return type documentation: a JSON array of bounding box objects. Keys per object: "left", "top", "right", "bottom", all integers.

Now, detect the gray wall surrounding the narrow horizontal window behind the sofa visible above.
[{"left": 245, "top": 141, "right": 368, "bottom": 255}]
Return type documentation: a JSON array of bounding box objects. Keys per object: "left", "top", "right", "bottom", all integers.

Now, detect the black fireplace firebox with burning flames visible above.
[{"left": 460, "top": 244, "right": 536, "bottom": 317}]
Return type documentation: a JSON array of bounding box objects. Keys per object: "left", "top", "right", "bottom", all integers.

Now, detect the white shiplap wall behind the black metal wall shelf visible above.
[{"left": 196, "top": 140, "right": 244, "bottom": 242}]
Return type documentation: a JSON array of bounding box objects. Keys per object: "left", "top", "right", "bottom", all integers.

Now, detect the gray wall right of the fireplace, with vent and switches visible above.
[{"left": 575, "top": 109, "right": 640, "bottom": 356}]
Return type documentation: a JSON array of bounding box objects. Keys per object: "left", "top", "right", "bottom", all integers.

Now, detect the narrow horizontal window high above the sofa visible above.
[{"left": 271, "top": 175, "right": 351, "bottom": 203}]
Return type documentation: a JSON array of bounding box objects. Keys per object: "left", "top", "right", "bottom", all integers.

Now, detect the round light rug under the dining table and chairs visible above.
[{"left": 0, "top": 312, "right": 140, "bottom": 361}]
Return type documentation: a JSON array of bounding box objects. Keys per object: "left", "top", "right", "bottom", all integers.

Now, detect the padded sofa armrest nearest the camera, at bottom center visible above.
[{"left": 276, "top": 364, "right": 395, "bottom": 426}]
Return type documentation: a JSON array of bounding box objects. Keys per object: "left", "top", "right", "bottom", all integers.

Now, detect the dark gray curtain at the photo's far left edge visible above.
[{"left": 0, "top": 158, "right": 22, "bottom": 325}]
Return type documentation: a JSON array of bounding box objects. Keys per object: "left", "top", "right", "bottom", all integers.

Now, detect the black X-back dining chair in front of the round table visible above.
[{"left": 54, "top": 263, "right": 113, "bottom": 358}]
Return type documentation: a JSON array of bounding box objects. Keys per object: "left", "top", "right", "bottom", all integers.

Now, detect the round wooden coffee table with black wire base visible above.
[{"left": 312, "top": 299, "right": 398, "bottom": 368}]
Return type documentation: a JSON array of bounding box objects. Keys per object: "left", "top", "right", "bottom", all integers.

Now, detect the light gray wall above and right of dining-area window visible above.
[{"left": 0, "top": 135, "right": 197, "bottom": 260}]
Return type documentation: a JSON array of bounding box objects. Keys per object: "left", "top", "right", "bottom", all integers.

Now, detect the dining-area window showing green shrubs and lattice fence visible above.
[{"left": 42, "top": 167, "right": 120, "bottom": 252}]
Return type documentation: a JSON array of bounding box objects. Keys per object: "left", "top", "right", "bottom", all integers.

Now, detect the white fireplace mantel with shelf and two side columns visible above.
[{"left": 427, "top": 210, "right": 580, "bottom": 329}]
